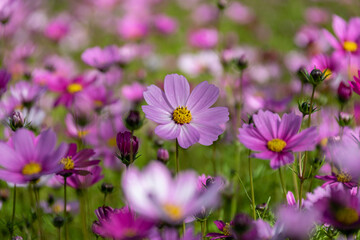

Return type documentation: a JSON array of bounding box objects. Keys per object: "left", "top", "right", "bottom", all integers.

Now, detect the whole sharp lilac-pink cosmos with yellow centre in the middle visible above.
[{"left": 142, "top": 74, "right": 229, "bottom": 148}]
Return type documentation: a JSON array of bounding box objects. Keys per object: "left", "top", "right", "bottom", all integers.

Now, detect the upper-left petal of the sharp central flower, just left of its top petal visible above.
[{"left": 143, "top": 85, "right": 174, "bottom": 113}]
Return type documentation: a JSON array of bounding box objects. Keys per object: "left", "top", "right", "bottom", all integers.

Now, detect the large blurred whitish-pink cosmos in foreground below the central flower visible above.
[{"left": 122, "top": 161, "right": 218, "bottom": 224}]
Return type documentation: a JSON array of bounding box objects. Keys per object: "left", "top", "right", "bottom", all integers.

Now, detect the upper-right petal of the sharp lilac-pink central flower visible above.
[{"left": 186, "top": 81, "right": 219, "bottom": 114}]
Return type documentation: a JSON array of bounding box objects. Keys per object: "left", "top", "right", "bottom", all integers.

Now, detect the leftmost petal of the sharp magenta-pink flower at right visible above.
[{"left": 238, "top": 124, "right": 268, "bottom": 151}]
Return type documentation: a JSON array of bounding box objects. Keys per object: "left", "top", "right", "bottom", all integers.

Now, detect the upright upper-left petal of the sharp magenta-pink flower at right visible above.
[{"left": 253, "top": 110, "right": 280, "bottom": 141}]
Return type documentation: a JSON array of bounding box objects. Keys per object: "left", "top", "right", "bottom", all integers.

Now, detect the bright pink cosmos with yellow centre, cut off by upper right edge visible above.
[{"left": 323, "top": 15, "right": 360, "bottom": 57}]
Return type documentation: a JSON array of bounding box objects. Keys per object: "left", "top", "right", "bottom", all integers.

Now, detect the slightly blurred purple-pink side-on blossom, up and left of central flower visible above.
[{"left": 81, "top": 45, "right": 120, "bottom": 72}]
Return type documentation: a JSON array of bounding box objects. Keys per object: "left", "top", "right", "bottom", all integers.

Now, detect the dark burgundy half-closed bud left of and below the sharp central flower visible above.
[{"left": 116, "top": 131, "right": 139, "bottom": 166}]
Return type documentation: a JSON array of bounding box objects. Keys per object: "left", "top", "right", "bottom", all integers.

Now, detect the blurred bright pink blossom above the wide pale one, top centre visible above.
[{"left": 189, "top": 28, "right": 218, "bottom": 49}]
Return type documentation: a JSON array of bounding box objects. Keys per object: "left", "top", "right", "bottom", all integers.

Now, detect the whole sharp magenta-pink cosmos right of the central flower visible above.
[{"left": 238, "top": 110, "right": 317, "bottom": 169}]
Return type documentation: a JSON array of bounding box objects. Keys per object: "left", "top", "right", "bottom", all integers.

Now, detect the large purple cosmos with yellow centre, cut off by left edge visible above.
[{"left": 0, "top": 129, "right": 67, "bottom": 183}]
